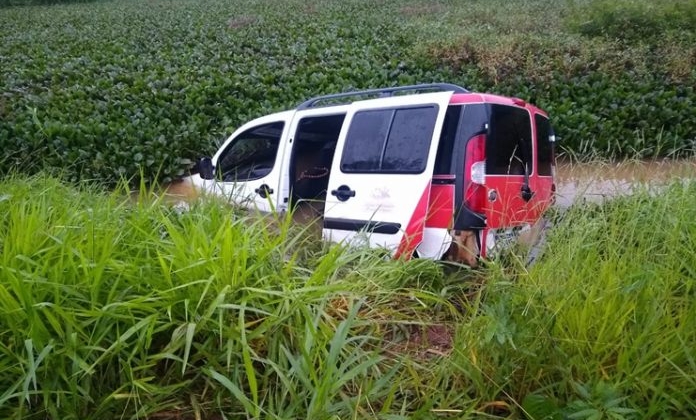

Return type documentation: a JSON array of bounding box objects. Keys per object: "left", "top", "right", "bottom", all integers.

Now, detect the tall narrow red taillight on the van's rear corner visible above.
[{"left": 464, "top": 134, "right": 486, "bottom": 213}]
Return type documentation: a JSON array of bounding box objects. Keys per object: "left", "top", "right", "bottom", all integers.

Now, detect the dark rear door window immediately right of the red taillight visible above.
[{"left": 486, "top": 105, "right": 532, "bottom": 175}]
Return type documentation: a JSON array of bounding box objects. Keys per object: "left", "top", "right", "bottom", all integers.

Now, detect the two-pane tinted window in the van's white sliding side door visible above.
[{"left": 341, "top": 105, "right": 438, "bottom": 174}]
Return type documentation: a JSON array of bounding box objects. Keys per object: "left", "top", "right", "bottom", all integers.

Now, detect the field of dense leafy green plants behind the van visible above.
[{"left": 0, "top": 0, "right": 696, "bottom": 185}]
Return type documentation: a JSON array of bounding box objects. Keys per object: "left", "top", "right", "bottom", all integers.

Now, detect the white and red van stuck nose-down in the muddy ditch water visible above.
[{"left": 191, "top": 84, "right": 555, "bottom": 264}]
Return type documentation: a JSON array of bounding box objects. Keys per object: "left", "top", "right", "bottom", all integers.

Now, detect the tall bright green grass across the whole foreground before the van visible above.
[{"left": 0, "top": 176, "right": 696, "bottom": 419}]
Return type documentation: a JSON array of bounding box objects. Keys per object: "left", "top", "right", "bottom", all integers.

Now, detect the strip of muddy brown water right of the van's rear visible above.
[{"left": 556, "top": 160, "right": 696, "bottom": 208}]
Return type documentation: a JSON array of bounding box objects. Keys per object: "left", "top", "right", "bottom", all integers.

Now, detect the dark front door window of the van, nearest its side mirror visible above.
[{"left": 217, "top": 122, "right": 284, "bottom": 182}]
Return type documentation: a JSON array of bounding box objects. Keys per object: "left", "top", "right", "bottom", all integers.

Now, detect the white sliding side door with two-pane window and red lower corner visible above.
[{"left": 323, "top": 92, "right": 452, "bottom": 256}]
